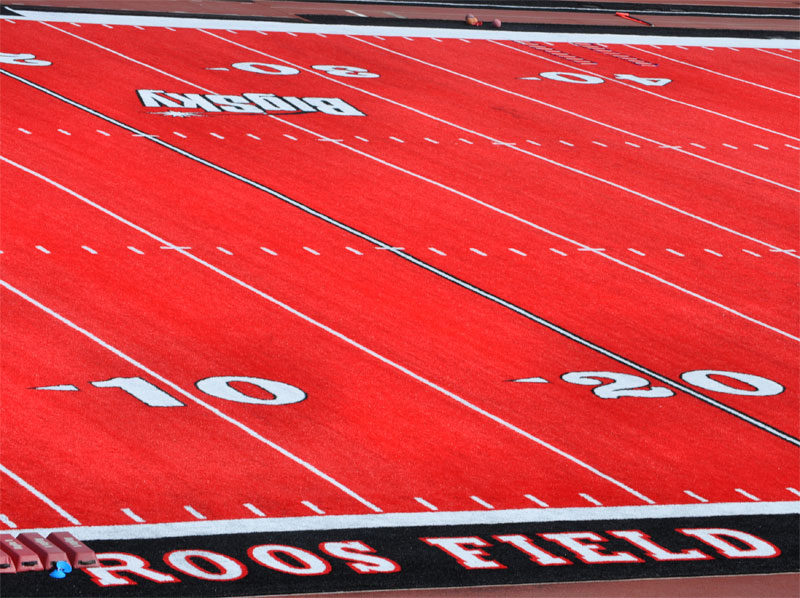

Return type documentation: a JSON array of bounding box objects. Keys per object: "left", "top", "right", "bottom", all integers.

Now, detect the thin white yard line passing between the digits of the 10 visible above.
[{"left": 0, "top": 284, "right": 381, "bottom": 512}]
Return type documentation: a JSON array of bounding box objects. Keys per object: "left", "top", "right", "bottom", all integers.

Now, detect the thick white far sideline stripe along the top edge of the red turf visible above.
[{"left": 0, "top": 9, "right": 800, "bottom": 49}]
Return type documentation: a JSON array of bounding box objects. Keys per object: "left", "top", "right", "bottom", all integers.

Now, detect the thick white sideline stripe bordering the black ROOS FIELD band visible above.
[{"left": 14, "top": 502, "right": 800, "bottom": 542}]
